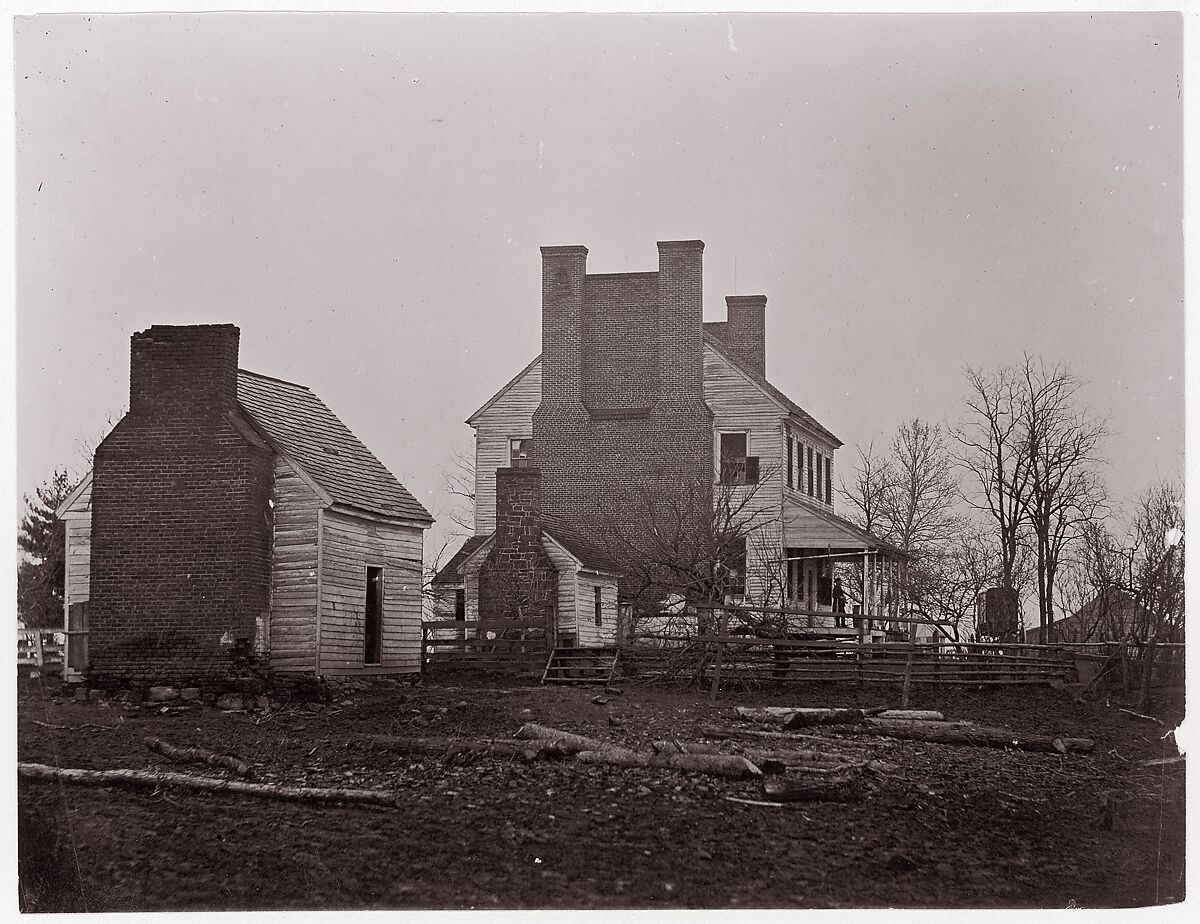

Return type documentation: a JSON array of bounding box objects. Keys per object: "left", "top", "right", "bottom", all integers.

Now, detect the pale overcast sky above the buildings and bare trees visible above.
[{"left": 14, "top": 13, "right": 1183, "bottom": 554}]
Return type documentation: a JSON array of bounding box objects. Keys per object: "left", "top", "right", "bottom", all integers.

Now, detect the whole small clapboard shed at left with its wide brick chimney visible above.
[{"left": 59, "top": 325, "right": 432, "bottom": 682}]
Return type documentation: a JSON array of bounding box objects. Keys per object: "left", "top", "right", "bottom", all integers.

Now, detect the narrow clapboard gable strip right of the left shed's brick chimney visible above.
[{"left": 268, "top": 456, "right": 320, "bottom": 671}]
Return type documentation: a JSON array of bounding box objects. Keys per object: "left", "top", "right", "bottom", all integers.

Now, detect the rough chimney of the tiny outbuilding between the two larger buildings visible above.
[{"left": 479, "top": 468, "right": 558, "bottom": 619}]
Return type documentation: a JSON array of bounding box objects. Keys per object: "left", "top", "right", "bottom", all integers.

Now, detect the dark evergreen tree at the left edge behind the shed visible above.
[{"left": 17, "top": 469, "right": 76, "bottom": 629}]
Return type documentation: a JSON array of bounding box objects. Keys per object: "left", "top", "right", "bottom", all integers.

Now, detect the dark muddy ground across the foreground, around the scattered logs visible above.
[{"left": 18, "top": 678, "right": 1184, "bottom": 911}]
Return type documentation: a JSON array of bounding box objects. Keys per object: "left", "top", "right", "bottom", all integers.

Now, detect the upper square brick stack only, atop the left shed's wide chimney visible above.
[{"left": 130, "top": 324, "right": 240, "bottom": 418}]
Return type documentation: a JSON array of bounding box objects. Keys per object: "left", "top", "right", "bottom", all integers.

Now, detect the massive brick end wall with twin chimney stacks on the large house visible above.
[{"left": 533, "top": 241, "right": 713, "bottom": 583}]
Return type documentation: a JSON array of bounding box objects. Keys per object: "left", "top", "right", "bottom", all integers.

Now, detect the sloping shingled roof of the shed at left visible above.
[{"left": 238, "top": 370, "right": 433, "bottom": 523}]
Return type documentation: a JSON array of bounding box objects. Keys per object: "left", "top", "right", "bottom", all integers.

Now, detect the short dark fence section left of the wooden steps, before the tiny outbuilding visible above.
[{"left": 421, "top": 618, "right": 550, "bottom": 673}]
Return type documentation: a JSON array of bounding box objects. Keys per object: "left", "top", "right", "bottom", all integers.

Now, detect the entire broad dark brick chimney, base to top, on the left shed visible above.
[{"left": 89, "top": 324, "right": 272, "bottom": 682}]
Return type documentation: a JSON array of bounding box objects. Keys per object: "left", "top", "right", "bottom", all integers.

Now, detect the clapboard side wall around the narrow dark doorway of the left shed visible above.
[{"left": 318, "top": 510, "right": 421, "bottom": 673}]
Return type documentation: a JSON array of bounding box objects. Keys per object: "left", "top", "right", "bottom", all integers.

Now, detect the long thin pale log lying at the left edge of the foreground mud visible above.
[{"left": 17, "top": 763, "right": 400, "bottom": 808}]
